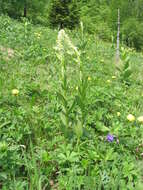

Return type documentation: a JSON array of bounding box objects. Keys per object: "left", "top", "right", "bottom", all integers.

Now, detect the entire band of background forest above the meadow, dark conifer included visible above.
[{"left": 0, "top": 0, "right": 143, "bottom": 51}]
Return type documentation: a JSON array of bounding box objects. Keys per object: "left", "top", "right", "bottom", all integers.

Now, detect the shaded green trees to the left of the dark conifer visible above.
[{"left": 0, "top": 0, "right": 49, "bottom": 23}]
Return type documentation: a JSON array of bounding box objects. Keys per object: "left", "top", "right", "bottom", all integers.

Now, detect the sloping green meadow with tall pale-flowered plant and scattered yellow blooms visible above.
[{"left": 0, "top": 16, "right": 143, "bottom": 190}]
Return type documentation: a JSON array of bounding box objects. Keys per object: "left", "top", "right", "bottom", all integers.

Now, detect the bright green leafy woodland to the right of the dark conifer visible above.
[{"left": 80, "top": 0, "right": 143, "bottom": 50}]
